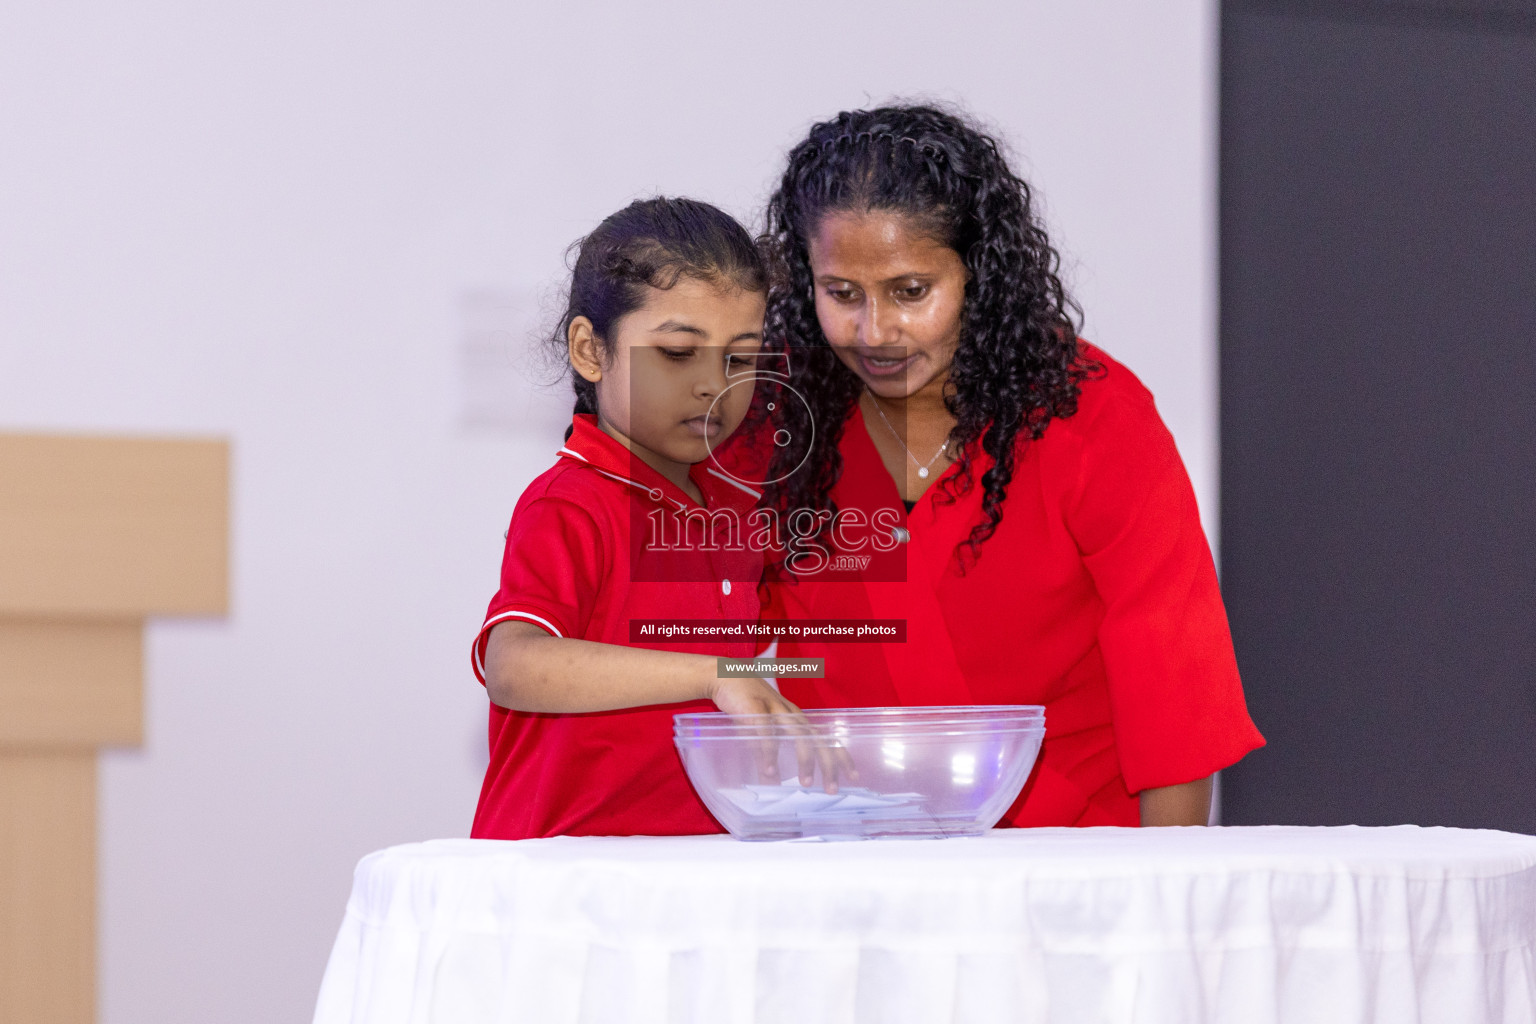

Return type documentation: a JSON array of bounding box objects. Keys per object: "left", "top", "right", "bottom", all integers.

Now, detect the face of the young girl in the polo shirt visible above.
[{"left": 571, "top": 276, "right": 765, "bottom": 484}]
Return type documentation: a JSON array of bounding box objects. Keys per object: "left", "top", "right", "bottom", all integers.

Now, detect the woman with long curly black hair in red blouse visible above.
[{"left": 759, "top": 106, "right": 1264, "bottom": 826}]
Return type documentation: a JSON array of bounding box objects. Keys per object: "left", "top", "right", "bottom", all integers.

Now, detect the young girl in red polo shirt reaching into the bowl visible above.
[{"left": 472, "top": 198, "right": 796, "bottom": 838}]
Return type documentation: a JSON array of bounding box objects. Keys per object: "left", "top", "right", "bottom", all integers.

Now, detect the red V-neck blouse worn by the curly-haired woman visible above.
[{"left": 771, "top": 348, "right": 1264, "bottom": 826}]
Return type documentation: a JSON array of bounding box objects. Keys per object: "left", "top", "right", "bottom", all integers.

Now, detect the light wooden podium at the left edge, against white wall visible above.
[{"left": 0, "top": 434, "right": 229, "bottom": 1024}]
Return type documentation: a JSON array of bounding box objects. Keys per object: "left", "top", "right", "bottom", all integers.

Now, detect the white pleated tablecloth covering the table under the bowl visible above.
[{"left": 315, "top": 826, "right": 1536, "bottom": 1024}]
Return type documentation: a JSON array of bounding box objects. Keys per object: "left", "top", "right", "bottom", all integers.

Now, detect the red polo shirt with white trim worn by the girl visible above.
[{"left": 472, "top": 415, "right": 762, "bottom": 840}]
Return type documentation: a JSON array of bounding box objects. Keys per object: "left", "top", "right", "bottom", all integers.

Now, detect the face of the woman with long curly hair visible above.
[{"left": 806, "top": 210, "right": 971, "bottom": 399}]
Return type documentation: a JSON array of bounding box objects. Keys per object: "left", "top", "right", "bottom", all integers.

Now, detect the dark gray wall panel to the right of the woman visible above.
[{"left": 1221, "top": 10, "right": 1536, "bottom": 832}]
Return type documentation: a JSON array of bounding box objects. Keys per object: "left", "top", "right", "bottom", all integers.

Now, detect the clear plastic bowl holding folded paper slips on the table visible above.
[{"left": 673, "top": 705, "right": 1044, "bottom": 840}]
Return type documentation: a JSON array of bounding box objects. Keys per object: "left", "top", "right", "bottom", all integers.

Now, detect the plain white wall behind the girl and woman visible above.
[{"left": 0, "top": 0, "right": 1217, "bottom": 1024}]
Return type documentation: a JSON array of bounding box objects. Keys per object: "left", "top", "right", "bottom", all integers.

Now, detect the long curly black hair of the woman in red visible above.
[{"left": 763, "top": 106, "right": 1100, "bottom": 570}]
